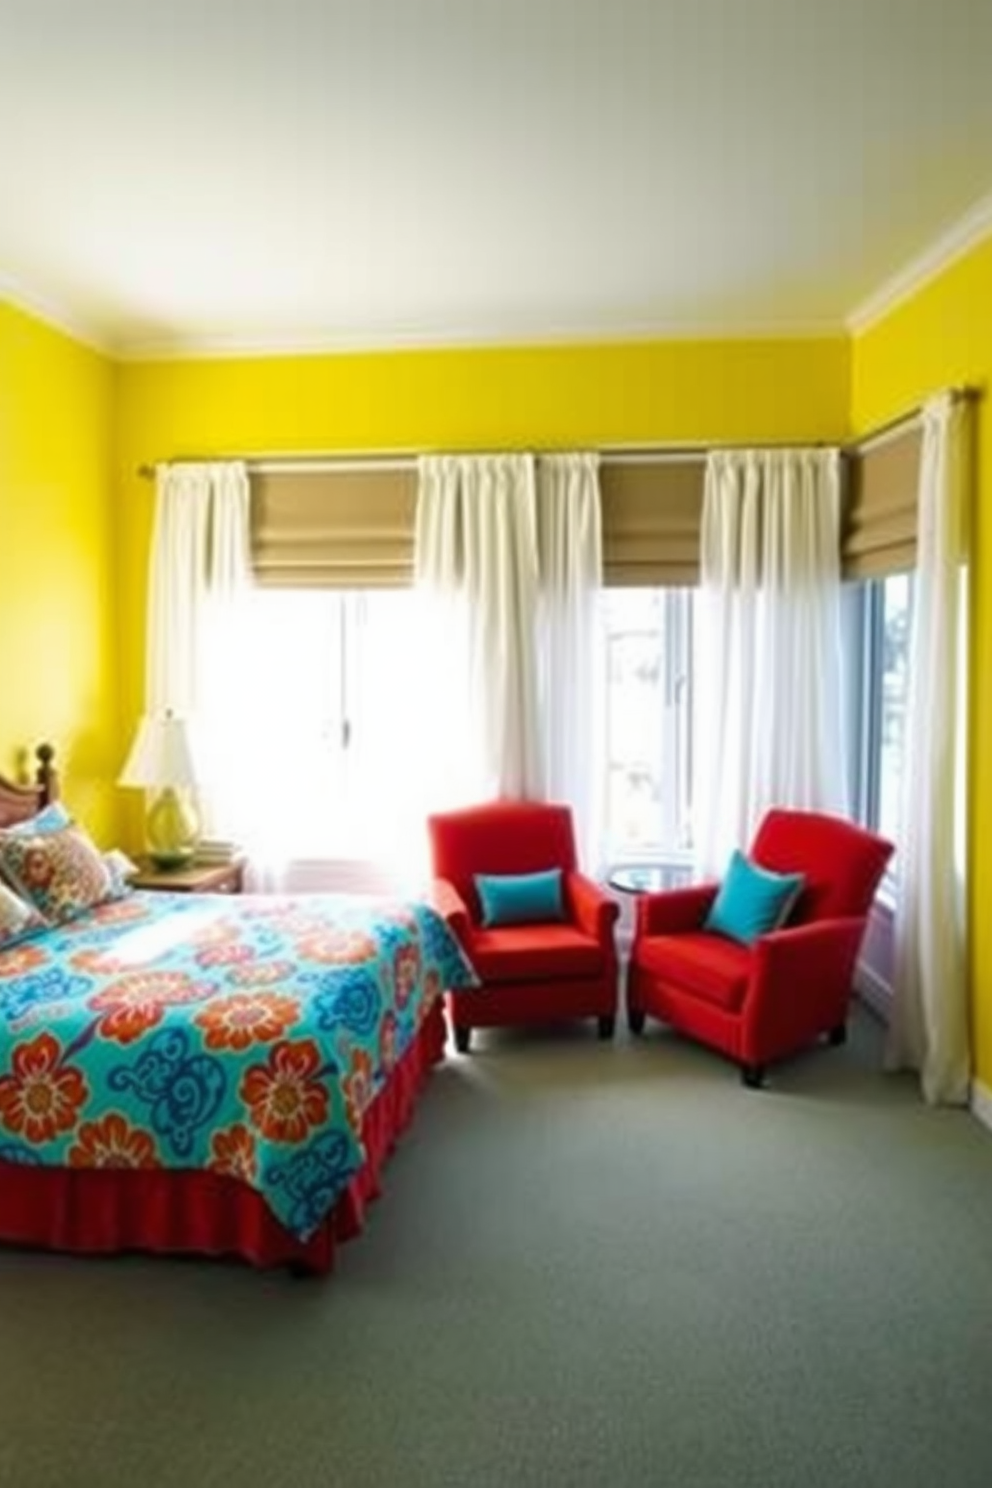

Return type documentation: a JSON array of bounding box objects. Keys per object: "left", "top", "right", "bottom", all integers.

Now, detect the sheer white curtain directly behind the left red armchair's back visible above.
[{"left": 415, "top": 455, "right": 544, "bottom": 805}]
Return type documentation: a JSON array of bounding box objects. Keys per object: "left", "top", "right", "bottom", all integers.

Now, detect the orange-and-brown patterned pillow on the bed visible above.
[{"left": 0, "top": 823, "right": 117, "bottom": 924}]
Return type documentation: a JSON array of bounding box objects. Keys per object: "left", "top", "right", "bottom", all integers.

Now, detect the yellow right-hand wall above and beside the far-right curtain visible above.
[{"left": 851, "top": 238, "right": 992, "bottom": 1086}]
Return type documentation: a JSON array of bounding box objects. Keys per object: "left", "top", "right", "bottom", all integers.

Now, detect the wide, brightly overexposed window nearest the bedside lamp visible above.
[{"left": 210, "top": 589, "right": 422, "bottom": 863}]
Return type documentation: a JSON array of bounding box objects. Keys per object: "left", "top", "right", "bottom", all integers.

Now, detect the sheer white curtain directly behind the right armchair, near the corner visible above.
[{"left": 693, "top": 449, "right": 848, "bottom": 875}]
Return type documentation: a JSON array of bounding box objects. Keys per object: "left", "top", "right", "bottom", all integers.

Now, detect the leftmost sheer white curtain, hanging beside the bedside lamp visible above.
[{"left": 146, "top": 461, "right": 251, "bottom": 832}]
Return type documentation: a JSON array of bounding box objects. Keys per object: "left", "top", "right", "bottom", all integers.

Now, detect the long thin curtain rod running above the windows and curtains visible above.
[{"left": 137, "top": 384, "right": 983, "bottom": 481}]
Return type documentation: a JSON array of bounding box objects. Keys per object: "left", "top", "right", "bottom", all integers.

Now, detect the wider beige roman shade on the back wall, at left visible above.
[{"left": 250, "top": 463, "right": 416, "bottom": 589}]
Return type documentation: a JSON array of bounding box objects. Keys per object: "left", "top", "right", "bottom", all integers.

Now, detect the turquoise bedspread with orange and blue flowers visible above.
[{"left": 0, "top": 893, "right": 476, "bottom": 1240}]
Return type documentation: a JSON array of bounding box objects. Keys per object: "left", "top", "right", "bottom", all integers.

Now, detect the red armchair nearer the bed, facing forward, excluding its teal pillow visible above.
[{"left": 427, "top": 801, "right": 619, "bottom": 1054}]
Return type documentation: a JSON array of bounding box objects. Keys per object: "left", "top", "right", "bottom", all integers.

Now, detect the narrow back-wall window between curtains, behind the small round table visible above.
[{"left": 604, "top": 588, "right": 693, "bottom": 863}]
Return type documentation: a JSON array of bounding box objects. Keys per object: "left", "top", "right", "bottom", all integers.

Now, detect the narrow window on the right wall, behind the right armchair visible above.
[{"left": 846, "top": 573, "right": 913, "bottom": 868}]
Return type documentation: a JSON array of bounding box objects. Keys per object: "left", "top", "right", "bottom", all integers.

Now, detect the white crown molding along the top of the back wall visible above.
[{"left": 115, "top": 320, "right": 848, "bottom": 363}]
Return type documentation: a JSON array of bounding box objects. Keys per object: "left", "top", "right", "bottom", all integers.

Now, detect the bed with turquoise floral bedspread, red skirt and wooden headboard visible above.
[{"left": 0, "top": 745, "right": 474, "bottom": 1274}]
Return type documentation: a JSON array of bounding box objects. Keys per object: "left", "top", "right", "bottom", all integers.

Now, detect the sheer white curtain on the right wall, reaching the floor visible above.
[{"left": 886, "top": 394, "right": 971, "bottom": 1104}]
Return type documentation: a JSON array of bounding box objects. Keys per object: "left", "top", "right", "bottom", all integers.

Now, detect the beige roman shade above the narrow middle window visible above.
[{"left": 599, "top": 455, "right": 705, "bottom": 588}]
